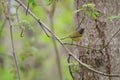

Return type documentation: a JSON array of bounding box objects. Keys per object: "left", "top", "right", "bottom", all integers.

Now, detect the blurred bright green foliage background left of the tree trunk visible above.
[{"left": 0, "top": 0, "right": 74, "bottom": 80}]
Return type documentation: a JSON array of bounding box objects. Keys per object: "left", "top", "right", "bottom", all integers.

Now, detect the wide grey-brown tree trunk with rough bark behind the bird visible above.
[{"left": 73, "top": 0, "right": 120, "bottom": 80}]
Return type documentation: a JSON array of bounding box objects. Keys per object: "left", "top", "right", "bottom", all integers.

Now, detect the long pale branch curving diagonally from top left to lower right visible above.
[{"left": 15, "top": 0, "right": 120, "bottom": 77}]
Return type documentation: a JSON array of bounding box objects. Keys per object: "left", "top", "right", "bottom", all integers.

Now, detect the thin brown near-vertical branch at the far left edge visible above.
[{"left": 2, "top": 0, "right": 21, "bottom": 80}]
